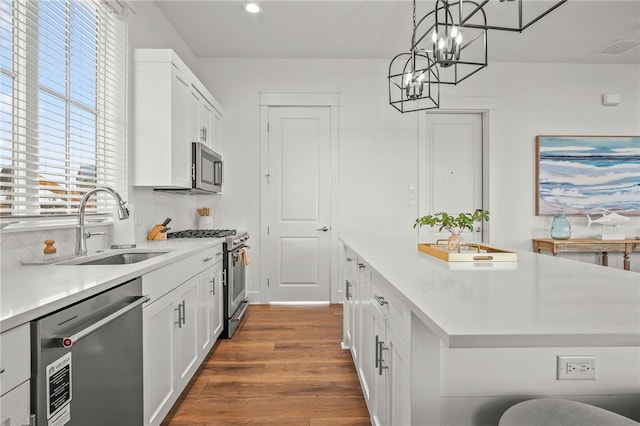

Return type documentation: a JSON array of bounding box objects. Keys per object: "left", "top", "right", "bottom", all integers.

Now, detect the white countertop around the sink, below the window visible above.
[{"left": 0, "top": 238, "right": 224, "bottom": 332}]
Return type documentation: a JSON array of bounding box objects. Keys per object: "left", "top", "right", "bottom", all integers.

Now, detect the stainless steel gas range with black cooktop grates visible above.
[{"left": 167, "top": 229, "right": 249, "bottom": 339}]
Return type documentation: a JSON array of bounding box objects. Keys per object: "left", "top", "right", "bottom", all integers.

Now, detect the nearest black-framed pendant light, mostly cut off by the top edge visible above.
[{"left": 460, "top": 0, "right": 567, "bottom": 32}]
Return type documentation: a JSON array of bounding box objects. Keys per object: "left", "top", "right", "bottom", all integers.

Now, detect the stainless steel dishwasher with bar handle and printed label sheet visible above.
[{"left": 31, "top": 278, "right": 148, "bottom": 426}]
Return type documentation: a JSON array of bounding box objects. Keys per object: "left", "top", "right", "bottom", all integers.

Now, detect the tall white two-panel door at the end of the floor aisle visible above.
[{"left": 263, "top": 107, "right": 331, "bottom": 302}]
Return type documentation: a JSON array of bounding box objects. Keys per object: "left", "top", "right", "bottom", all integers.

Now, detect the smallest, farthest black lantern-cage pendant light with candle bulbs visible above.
[{"left": 388, "top": 0, "right": 440, "bottom": 113}]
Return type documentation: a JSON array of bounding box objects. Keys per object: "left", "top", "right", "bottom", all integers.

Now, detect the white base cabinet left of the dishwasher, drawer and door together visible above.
[{"left": 0, "top": 324, "right": 31, "bottom": 426}]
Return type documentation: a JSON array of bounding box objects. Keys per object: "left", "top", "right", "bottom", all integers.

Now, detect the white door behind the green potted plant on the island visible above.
[{"left": 419, "top": 113, "right": 483, "bottom": 243}]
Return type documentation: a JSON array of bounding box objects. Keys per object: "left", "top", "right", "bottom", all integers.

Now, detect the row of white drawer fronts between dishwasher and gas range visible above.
[{"left": 142, "top": 244, "right": 223, "bottom": 305}]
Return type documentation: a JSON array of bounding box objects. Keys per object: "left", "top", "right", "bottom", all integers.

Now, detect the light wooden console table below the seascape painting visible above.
[{"left": 532, "top": 238, "right": 640, "bottom": 271}]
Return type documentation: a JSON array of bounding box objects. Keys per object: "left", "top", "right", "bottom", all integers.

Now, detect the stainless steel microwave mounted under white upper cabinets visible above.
[{"left": 191, "top": 142, "right": 223, "bottom": 193}]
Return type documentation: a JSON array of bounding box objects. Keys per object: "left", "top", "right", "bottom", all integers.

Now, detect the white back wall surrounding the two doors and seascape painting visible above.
[{"left": 199, "top": 58, "right": 640, "bottom": 291}]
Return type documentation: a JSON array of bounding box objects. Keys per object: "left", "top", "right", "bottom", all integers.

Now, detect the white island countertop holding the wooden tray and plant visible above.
[{"left": 341, "top": 236, "right": 640, "bottom": 348}]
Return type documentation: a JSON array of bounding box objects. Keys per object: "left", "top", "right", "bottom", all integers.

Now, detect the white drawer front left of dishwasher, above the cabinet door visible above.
[{"left": 0, "top": 324, "right": 31, "bottom": 395}]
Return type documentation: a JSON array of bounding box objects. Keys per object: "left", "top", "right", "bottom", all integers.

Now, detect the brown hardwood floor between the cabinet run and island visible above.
[{"left": 162, "top": 305, "right": 370, "bottom": 426}]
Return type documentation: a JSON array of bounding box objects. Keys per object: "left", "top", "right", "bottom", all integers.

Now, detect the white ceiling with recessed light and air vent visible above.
[{"left": 151, "top": 0, "right": 640, "bottom": 64}]
